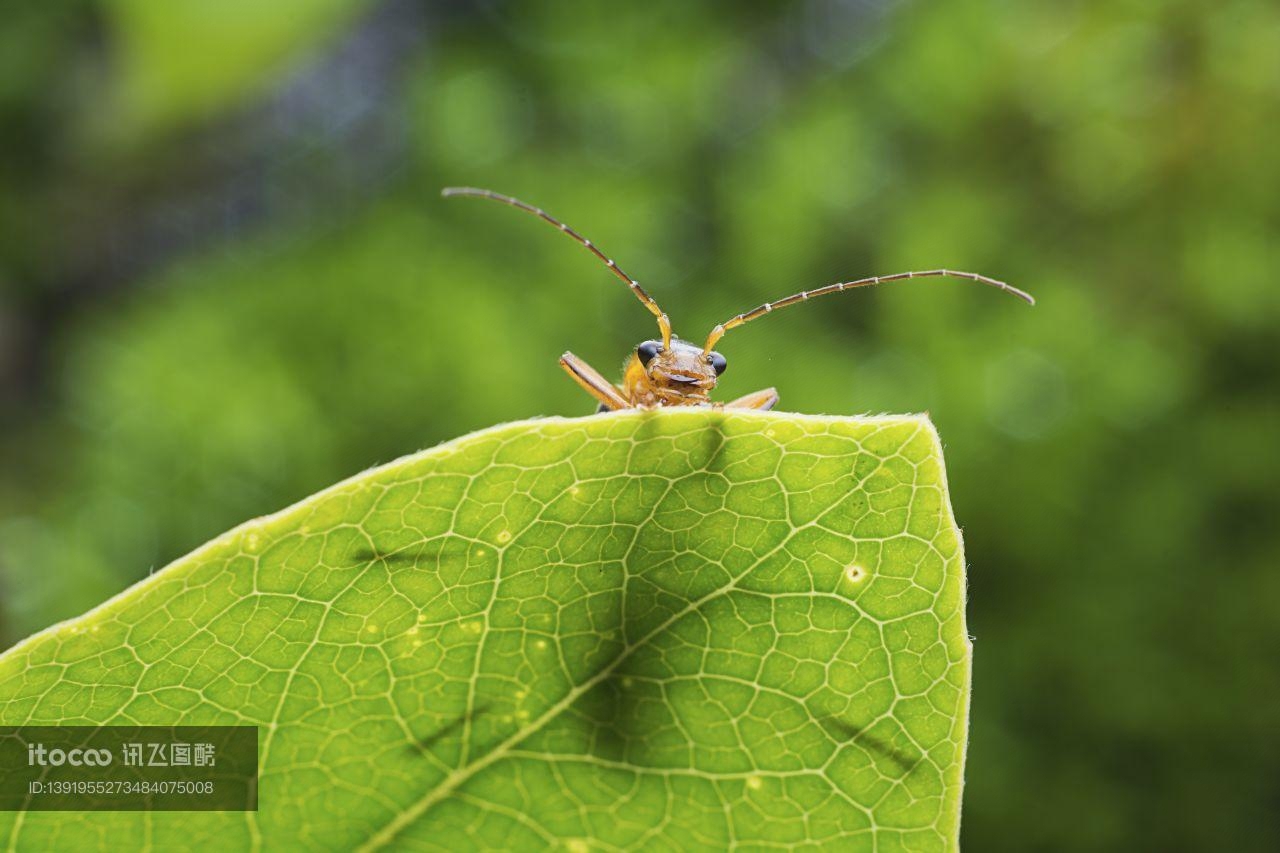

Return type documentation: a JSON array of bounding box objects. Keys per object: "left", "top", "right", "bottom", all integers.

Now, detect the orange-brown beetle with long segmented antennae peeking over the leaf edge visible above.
[{"left": 442, "top": 187, "right": 1036, "bottom": 411}]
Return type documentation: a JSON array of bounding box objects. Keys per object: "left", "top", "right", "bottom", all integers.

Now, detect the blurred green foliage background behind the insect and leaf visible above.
[{"left": 0, "top": 0, "right": 1280, "bottom": 850}]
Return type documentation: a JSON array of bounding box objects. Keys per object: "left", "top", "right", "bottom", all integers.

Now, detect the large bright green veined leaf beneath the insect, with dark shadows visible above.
[{"left": 0, "top": 410, "right": 969, "bottom": 850}]
